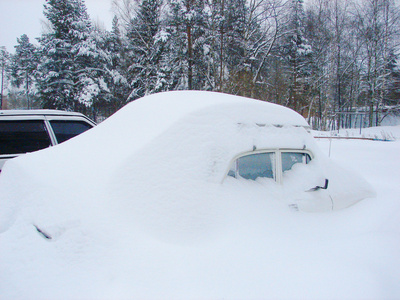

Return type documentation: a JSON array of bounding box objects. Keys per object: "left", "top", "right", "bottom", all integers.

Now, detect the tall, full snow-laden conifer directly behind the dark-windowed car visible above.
[{"left": 38, "top": 0, "right": 110, "bottom": 113}]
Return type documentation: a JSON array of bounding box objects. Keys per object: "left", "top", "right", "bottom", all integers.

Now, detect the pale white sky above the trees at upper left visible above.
[{"left": 0, "top": 0, "right": 113, "bottom": 52}]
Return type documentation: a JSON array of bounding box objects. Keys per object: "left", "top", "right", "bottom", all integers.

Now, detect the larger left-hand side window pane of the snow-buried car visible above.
[{"left": 237, "top": 152, "right": 275, "bottom": 180}]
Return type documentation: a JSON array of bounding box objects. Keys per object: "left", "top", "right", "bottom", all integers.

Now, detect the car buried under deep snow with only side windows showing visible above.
[{"left": 0, "top": 91, "right": 374, "bottom": 225}]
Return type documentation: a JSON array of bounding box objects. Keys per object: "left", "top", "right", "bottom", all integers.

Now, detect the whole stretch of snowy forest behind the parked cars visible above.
[{"left": 0, "top": 0, "right": 400, "bottom": 129}]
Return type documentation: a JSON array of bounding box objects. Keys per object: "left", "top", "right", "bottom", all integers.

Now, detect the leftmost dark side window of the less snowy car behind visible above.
[{"left": 0, "top": 120, "right": 51, "bottom": 154}]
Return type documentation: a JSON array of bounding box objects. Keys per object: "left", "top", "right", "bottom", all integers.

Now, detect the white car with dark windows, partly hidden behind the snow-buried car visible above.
[{"left": 0, "top": 109, "right": 95, "bottom": 172}]
